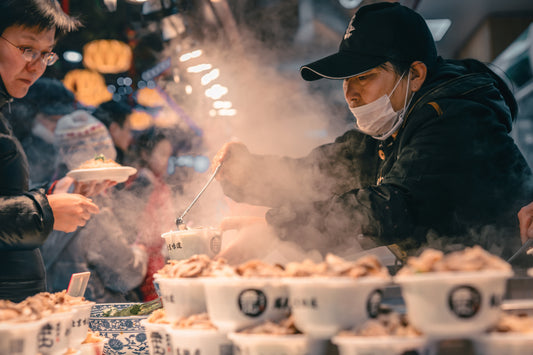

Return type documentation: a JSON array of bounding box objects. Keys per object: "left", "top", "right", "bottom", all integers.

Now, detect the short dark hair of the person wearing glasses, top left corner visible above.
[{"left": 0, "top": 0, "right": 81, "bottom": 34}]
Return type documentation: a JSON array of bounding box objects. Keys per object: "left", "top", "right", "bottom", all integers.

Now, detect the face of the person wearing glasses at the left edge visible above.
[{"left": 0, "top": 26, "right": 55, "bottom": 98}]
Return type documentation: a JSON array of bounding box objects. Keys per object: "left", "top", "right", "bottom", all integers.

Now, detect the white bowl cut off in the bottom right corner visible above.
[{"left": 474, "top": 333, "right": 533, "bottom": 355}]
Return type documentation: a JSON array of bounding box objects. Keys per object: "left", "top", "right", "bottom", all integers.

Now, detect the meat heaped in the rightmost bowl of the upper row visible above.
[{"left": 397, "top": 245, "right": 512, "bottom": 275}]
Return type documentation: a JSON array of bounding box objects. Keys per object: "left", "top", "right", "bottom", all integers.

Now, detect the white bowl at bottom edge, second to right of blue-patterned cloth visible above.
[{"left": 165, "top": 325, "right": 233, "bottom": 355}]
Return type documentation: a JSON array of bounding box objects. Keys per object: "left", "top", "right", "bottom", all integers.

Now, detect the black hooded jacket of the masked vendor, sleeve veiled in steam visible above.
[{"left": 219, "top": 59, "right": 533, "bottom": 257}]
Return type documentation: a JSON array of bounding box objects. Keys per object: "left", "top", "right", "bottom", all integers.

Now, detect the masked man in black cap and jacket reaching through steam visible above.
[{"left": 214, "top": 2, "right": 532, "bottom": 259}]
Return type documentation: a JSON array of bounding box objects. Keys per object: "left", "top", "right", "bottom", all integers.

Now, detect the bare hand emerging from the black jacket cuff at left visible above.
[{"left": 48, "top": 193, "right": 100, "bottom": 233}]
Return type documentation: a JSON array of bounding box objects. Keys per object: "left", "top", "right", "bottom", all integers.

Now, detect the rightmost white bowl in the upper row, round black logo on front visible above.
[{"left": 395, "top": 270, "right": 512, "bottom": 338}]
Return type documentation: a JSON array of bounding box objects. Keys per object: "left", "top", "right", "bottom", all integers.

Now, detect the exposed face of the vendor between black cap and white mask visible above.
[{"left": 343, "top": 63, "right": 407, "bottom": 111}]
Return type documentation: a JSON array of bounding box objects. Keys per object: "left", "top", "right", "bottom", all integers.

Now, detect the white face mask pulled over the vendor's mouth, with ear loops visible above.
[{"left": 350, "top": 74, "right": 410, "bottom": 140}]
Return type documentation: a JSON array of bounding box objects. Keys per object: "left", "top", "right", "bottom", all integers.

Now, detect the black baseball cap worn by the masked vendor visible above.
[{"left": 300, "top": 2, "right": 437, "bottom": 81}]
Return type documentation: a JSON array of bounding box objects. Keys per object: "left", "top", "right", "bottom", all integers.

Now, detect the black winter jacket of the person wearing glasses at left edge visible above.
[{"left": 0, "top": 81, "right": 54, "bottom": 302}]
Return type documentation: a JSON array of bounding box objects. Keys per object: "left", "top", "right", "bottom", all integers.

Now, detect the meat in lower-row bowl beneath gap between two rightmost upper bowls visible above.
[{"left": 338, "top": 312, "right": 422, "bottom": 337}]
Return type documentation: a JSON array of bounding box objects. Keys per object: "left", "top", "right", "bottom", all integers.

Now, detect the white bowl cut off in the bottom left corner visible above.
[{"left": 0, "top": 319, "right": 43, "bottom": 355}]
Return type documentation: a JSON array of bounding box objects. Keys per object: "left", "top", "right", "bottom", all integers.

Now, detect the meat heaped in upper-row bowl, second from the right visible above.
[{"left": 285, "top": 254, "right": 389, "bottom": 278}]
